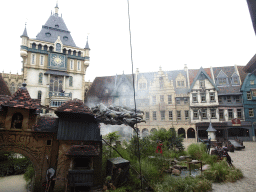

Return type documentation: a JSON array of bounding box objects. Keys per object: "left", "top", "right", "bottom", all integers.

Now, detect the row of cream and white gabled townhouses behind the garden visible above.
[{"left": 85, "top": 65, "right": 254, "bottom": 140}]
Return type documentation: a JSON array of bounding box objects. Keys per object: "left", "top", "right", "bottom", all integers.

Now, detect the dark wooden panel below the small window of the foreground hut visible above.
[{"left": 68, "top": 170, "right": 94, "bottom": 186}]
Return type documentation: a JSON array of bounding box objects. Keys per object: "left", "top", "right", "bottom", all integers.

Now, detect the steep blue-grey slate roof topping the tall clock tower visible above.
[{"left": 36, "top": 15, "right": 76, "bottom": 47}]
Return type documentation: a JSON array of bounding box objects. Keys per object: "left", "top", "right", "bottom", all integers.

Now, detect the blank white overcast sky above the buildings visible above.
[{"left": 0, "top": 0, "right": 256, "bottom": 81}]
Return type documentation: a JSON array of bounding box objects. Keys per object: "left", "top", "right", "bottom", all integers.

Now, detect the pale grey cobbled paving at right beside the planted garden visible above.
[{"left": 212, "top": 142, "right": 256, "bottom": 192}]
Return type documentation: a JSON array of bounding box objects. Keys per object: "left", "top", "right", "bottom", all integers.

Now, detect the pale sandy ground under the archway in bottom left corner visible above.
[{"left": 0, "top": 175, "right": 27, "bottom": 192}]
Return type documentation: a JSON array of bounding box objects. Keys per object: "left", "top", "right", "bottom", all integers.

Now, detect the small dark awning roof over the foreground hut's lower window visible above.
[{"left": 66, "top": 145, "right": 99, "bottom": 156}]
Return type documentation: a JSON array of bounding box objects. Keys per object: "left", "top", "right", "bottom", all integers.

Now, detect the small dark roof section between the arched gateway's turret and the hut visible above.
[{"left": 32, "top": 117, "right": 59, "bottom": 132}]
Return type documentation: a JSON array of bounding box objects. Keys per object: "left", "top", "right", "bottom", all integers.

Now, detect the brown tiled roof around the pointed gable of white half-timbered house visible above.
[{"left": 189, "top": 67, "right": 218, "bottom": 92}]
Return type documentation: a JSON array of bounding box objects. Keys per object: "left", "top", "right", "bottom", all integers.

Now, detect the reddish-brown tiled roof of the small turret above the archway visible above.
[{"left": 3, "top": 87, "right": 40, "bottom": 111}]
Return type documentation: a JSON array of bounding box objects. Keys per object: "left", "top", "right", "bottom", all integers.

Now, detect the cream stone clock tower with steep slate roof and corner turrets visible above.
[{"left": 20, "top": 5, "right": 90, "bottom": 108}]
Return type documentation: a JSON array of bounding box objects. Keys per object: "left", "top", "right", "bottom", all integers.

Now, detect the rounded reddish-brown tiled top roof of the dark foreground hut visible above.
[{"left": 55, "top": 99, "right": 93, "bottom": 115}]
